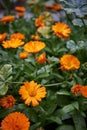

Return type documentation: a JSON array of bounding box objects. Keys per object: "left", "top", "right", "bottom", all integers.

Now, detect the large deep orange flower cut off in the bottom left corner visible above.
[{"left": 1, "top": 112, "right": 30, "bottom": 130}]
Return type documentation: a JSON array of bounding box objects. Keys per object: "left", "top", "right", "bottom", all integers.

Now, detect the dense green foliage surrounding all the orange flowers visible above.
[{"left": 0, "top": 0, "right": 87, "bottom": 130}]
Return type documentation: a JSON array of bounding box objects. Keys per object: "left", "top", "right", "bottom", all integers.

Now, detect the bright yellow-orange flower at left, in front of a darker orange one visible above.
[{"left": 2, "top": 38, "right": 24, "bottom": 48}]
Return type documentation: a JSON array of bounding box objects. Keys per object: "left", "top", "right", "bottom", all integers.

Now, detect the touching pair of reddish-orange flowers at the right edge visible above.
[{"left": 71, "top": 84, "right": 87, "bottom": 98}]
